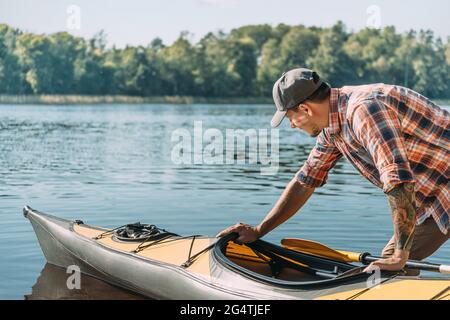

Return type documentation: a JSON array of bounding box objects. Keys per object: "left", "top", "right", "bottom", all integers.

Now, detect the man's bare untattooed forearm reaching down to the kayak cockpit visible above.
[{"left": 257, "top": 177, "right": 315, "bottom": 237}]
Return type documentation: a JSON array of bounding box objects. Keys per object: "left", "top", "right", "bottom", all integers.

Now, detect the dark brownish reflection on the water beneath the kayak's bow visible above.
[{"left": 25, "top": 263, "right": 146, "bottom": 300}]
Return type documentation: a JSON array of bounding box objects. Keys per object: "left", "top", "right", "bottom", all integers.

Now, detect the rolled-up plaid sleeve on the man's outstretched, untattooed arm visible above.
[{"left": 296, "top": 132, "right": 342, "bottom": 188}]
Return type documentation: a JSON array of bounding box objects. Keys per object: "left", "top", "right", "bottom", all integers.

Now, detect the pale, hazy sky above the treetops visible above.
[{"left": 0, "top": 0, "right": 450, "bottom": 48}]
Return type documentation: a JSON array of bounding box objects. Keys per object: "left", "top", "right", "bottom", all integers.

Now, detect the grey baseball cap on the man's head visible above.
[{"left": 270, "top": 68, "right": 323, "bottom": 128}]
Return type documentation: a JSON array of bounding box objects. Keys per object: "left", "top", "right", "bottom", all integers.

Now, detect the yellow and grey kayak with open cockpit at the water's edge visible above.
[{"left": 24, "top": 206, "right": 450, "bottom": 300}]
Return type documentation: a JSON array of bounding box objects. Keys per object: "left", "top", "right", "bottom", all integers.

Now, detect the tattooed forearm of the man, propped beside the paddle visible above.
[{"left": 388, "top": 183, "right": 416, "bottom": 251}]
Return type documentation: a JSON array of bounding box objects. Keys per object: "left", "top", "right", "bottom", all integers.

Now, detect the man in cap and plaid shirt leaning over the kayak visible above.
[{"left": 218, "top": 68, "right": 450, "bottom": 271}]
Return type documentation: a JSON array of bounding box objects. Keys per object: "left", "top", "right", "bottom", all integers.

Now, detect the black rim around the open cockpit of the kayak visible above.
[{"left": 212, "top": 234, "right": 382, "bottom": 289}]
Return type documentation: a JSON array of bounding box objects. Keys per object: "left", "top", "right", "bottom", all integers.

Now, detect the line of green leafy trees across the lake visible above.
[{"left": 0, "top": 22, "right": 450, "bottom": 98}]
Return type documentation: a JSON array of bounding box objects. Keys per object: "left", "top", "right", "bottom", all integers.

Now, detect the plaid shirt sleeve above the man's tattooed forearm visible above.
[{"left": 351, "top": 101, "right": 415, "bottom": 193}]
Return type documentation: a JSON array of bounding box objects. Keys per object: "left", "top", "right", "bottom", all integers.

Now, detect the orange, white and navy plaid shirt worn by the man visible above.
[{"left": 296, "top": 84, "right": 450, "bottom": 234}]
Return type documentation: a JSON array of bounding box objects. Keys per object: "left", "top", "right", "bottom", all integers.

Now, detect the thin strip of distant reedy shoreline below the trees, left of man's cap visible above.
[{"left": 0, "top": 95, "right": 273, "bottom": 105}]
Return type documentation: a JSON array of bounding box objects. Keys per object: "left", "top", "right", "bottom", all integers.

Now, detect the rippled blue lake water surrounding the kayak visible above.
[{"left": 0, "top": 105, "right": 450, "bottom": 299}]
